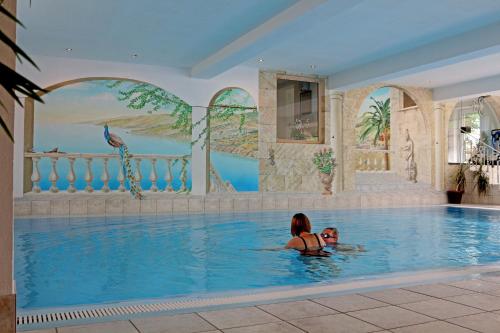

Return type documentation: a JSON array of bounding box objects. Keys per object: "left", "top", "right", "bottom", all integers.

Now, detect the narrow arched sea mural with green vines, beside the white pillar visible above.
[{"left": 210, "top": 88, "right": 259, "bottom": 191}]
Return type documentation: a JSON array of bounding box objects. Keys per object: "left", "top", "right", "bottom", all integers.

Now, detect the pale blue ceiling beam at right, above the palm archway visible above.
[{"left": 328, "top": 22, "right": 500, "bottom": 90}]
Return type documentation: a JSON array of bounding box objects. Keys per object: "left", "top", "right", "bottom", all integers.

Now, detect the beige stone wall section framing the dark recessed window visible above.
[{"left": 259, "top": 72, "right": 330, "bottom": 193}]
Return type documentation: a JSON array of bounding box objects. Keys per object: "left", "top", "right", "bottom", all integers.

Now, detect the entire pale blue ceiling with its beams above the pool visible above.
[{"left": 18, "top": 0, "right": 500, "bottom": 92}]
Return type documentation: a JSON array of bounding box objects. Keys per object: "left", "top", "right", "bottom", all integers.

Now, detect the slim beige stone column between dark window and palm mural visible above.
[{"left": 330, "top": 90, "right": 344, "bottom": 193}]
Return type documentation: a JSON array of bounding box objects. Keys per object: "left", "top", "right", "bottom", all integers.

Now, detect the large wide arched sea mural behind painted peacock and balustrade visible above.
[{"left": 25, "top": 77, "right": 192, "bottom": 190}]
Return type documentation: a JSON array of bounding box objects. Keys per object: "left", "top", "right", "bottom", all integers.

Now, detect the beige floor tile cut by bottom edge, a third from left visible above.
[{"left": 132, "top": 313, "right": 215, "bottom": 333}]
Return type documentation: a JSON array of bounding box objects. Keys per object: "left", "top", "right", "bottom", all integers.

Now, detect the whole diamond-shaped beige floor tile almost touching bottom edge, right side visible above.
[{"left": 348, "top": 306, "right": 435, "bottom": 329}]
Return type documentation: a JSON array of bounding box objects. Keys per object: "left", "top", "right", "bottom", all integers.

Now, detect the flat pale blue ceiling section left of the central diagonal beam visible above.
[{"left": 18, "top": 0, "right": 295, "bottom": 67}]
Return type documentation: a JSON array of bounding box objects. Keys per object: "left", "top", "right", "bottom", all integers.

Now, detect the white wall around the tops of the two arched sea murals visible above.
[{"left": 14, "top": 56, "right": 259, "bottom": 197}]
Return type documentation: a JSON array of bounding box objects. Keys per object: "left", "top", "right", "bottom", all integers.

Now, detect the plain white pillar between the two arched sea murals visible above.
[{"left": 191, "top": 107, "right": 210, "bottom": 195}]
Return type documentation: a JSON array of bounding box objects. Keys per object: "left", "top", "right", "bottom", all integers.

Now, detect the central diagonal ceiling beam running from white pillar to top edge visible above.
[{"left": 191, "top": 0, "right": 364, "bottom": 78}]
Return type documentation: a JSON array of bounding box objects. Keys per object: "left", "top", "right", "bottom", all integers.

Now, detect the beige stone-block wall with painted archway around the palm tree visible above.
[{"left": 343, "top": 83, "right": 433, "bottom": 190}]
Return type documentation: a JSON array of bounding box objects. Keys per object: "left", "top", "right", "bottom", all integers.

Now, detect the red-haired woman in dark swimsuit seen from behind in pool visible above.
[{"left": 286, "top": 213, "right": 331, "bottom": 257}]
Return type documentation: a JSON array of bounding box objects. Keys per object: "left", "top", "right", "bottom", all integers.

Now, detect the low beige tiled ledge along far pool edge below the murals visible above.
[{"left": 14, "top": 190, "right": 448, "bottom": 218}]
